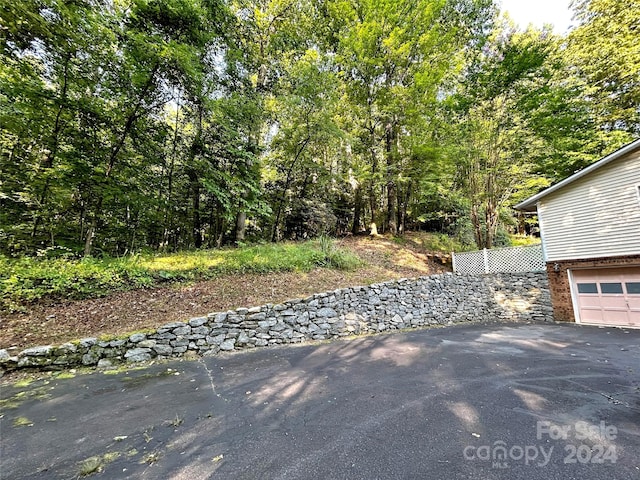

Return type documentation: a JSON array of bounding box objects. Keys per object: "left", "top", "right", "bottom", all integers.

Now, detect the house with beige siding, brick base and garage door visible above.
[{"left": 515, "top": 139, "right": 640, "bottom": 327}]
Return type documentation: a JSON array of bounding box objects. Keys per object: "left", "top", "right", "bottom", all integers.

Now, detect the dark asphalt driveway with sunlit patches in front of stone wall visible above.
[{"left": 0, "top": 324, "right": 640, "bottom": 480}]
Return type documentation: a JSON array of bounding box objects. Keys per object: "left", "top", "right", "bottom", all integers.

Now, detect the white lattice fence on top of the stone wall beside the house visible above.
[{"left": 452, "top": 245, "right": 545, "bottom": 275}]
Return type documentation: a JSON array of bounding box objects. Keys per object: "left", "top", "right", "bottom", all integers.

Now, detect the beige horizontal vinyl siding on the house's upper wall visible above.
[{"left": 538, "top": 151, "right": 640, "bottom": 261}]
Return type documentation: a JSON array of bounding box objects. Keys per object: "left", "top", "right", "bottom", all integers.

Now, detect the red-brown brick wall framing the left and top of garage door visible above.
[{"left": 547, "top": 255, "right": 640, "bottom": 322}]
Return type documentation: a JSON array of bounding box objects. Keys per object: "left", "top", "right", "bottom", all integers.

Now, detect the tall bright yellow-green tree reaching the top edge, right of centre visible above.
[{"left": 328, "top": 0, "right": 489, "bottom": 234}]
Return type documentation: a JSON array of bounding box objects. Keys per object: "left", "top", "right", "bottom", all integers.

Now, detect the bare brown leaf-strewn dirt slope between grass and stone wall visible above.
[{"left": 0, "top": 238, "right": 449, "bottom": 352}]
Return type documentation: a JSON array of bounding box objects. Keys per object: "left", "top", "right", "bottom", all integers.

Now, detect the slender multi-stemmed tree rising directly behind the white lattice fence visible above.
[{"left": 456, "top": 24, "right": 554, "bottom": 248}]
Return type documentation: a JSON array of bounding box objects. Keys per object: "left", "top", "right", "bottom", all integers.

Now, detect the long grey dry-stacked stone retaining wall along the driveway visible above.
[{"left": 0, "top": 273, "right": 553, "bottom": 370}]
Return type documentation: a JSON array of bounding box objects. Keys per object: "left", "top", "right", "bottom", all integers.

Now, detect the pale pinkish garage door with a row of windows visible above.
[{"left": 572, "top": 267, "right": 640, "bottom": 327}]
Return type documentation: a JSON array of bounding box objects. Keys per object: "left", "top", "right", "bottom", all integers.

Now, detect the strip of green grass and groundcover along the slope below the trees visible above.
[{"left": 0, "top": 239, "right": 360, "bottom": 311}]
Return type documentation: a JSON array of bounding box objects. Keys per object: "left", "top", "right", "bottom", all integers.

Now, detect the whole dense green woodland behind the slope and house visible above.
[{"left": 0, "top": 0, "right": 640, "bottom": 256}]
